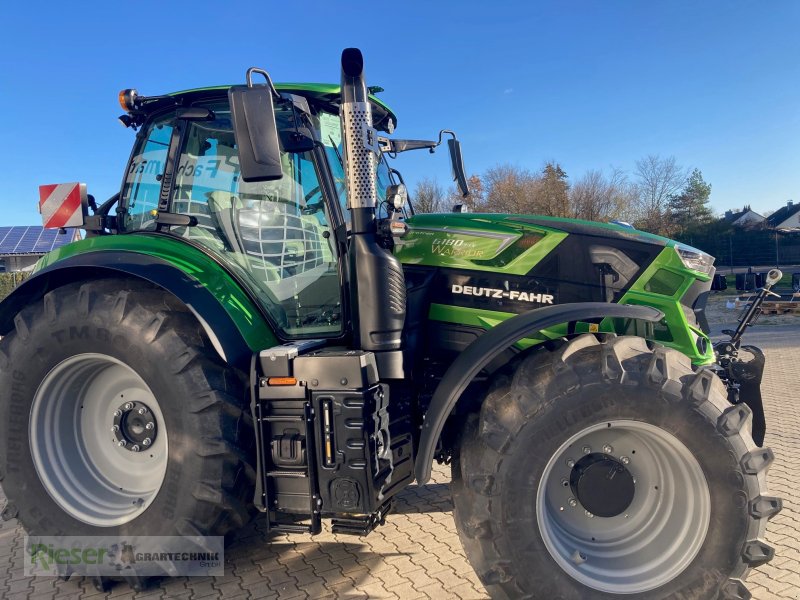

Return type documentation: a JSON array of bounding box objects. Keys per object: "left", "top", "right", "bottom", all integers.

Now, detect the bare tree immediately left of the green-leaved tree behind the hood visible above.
[{"left": 636, "top": 154, "right": 686, "bottom": 234}]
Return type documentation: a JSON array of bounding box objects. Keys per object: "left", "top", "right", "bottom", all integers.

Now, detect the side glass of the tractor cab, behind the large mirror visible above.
[{"left": 129, "top": 100, "right": 342, "bottom": 338}]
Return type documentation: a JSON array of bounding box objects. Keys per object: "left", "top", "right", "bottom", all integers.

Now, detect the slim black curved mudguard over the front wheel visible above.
[{"left": 414, "top": 302, "right": 664, "bottom": 484}]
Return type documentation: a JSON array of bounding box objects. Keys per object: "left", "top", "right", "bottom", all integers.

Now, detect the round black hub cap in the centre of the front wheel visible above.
[{"left": 569, "top": 453, "right": 636, "bottom": 517}]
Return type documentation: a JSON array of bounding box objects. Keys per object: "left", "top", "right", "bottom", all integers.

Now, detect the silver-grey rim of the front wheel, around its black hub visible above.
[{"left": 536, "top": 420, "right": 711, "bottom": 593}]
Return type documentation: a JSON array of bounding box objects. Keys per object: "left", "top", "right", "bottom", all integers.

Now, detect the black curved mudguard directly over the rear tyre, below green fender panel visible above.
[{"left": 0, "top": 251, "right": 275, "bottom": 372}]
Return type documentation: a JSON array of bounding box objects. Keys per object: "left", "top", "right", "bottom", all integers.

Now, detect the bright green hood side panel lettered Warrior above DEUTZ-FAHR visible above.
[{"left": 395, "top": 214, "right": 567, "bottom": 275}]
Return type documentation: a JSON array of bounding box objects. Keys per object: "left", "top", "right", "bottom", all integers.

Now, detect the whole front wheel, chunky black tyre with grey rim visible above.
[{"left": 453, "top": 335, "right": 781, "bottom": 600}]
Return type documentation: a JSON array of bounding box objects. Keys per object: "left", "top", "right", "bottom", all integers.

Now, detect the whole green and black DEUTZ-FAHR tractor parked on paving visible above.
[{"left": 0, "top": 49, "right": 781, "bottom": 600}]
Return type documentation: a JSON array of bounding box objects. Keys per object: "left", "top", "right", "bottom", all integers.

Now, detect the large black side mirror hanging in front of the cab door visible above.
[{"left": 228, "top": 69, "right": 283, "bottom": 182}]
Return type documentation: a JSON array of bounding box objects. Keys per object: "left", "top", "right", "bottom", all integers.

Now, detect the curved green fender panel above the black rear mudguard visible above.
[{"left": 35, "top": 233, "right": 278, "bottom": 352}]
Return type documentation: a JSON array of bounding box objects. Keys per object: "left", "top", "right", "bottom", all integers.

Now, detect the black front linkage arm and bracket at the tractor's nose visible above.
[{"left": 714, "top": 269, "right": 783, "bottom": 447}]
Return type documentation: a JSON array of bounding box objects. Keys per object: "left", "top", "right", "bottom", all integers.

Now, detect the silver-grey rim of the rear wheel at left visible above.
[{"left": 30, "top": 354, "right": 168, "bottom": 527}]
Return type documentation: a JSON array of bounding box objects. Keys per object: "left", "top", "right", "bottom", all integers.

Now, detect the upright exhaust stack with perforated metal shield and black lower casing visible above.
[{"left": 339, "top": 48, "right": 406, "bottom": 360}]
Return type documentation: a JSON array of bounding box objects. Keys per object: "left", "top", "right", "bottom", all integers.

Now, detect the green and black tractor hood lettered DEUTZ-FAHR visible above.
[{"left": 395, "top": 213, "right": 714, "bottom": 364}]
